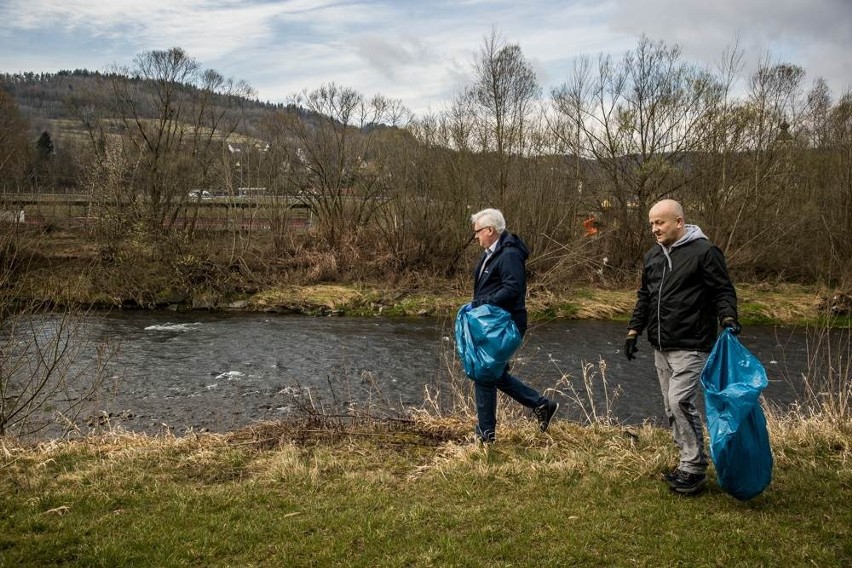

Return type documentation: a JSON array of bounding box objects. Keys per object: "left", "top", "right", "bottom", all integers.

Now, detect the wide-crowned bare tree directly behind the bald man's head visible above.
[{"left": 552, "top": 37, "right": 710, "bottom": 267}]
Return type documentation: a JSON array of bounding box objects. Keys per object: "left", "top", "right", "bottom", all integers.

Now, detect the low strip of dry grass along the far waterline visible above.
[{"left": 10, "top": 275, "right": 852, "bottom": 326}]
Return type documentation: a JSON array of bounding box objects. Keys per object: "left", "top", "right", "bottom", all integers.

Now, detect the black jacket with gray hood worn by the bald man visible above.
[{"left": 629, "top": 225, "right": 737, "bottom": 351}]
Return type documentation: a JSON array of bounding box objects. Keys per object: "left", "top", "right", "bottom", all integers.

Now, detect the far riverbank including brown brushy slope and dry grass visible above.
[{"left": 5, "top": 225, "right": 852, "bottom": 326}]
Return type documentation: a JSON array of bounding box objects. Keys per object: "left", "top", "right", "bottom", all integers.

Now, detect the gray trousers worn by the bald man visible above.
[{"left": 654, "top": 350, "right": 710, "bottom": 473}]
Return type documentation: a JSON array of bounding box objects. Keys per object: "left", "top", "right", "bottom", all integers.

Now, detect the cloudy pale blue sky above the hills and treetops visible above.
[{"left": 0, "top": 0, "right": 852, "bottom": 116}]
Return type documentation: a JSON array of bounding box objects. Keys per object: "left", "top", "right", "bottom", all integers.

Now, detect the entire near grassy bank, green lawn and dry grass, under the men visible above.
[{"left": 0, "top": 413, "right": 852, "bottom": 566}]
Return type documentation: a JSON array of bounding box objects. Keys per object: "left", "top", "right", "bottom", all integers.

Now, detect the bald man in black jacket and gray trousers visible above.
[{"left": 624, "top": 199, "right": 740, "bottom": 495}]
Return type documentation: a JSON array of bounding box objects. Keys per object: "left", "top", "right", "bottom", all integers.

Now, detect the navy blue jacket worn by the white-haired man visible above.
[{"left": 471, "top": 231, "right": 530, "bottom": 335}]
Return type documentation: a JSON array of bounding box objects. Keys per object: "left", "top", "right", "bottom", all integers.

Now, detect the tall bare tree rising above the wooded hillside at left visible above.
[{"left": 81, "top": 47, "right": 252, "bottom": 248}]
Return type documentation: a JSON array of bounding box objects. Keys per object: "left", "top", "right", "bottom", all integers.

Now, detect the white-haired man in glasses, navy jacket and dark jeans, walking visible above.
[{"left": 470, "top": 209, "right": 559, "bottom": 443}]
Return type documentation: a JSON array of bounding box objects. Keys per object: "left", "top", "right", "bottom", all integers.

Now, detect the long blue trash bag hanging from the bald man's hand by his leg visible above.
[{"left": 701, "top": 329, "right": 772, "bottom": 501}]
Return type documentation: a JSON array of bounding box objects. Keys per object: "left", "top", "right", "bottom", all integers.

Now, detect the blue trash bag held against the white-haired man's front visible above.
[{"left": 456, "top": 304, "right": 521, "bottom": 383}]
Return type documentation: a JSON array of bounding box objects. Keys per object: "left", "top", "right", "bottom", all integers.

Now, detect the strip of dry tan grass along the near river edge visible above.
[{"left": 0, "top": 413, "right": 852, "bottom": 492}]
